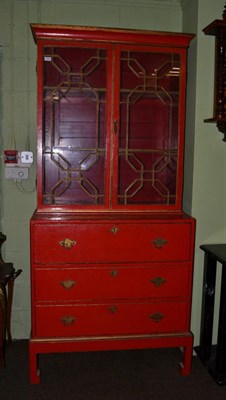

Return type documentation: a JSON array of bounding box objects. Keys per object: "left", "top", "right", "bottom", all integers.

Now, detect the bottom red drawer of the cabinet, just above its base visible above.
[{"left": 33, "top": 302, "right": 188, "bottom": 338}]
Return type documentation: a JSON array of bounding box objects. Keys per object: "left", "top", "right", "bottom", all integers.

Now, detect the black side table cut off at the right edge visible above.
[{"left": 195, "top": 244, "right": 226, "bottom": 385}]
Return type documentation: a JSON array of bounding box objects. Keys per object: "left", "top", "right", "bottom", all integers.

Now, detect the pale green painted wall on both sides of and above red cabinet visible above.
[{"left": 0, "top": 0, "right": 226, "bottom": 346}]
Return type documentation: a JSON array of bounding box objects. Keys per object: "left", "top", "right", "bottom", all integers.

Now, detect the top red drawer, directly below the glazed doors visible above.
[{"left": 32, "top": 223, "right": 191, "bottom": 264}]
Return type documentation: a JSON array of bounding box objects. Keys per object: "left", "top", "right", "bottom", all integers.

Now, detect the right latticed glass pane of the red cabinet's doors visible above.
[{"left": 118, "top": 51, "right": 180, "bottom": 205}]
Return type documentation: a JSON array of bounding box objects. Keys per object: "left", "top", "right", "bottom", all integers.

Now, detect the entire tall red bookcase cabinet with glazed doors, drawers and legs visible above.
[{"left": 30, "top": 25, "right": 195, "bottom": 383}]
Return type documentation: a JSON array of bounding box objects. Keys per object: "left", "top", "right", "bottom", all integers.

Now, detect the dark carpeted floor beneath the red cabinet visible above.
[{"left": 0, "top": 340, "right": 226, "bottom": 400}]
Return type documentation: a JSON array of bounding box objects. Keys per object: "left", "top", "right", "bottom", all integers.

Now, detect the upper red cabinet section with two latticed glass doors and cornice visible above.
[{"left": 31, "top": 24, "right": 193, "bottom": 212}]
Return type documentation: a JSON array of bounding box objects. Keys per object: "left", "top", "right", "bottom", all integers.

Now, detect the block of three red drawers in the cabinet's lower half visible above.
[{"left": 31, "top": 217, "right": 195, "bottom": 338}]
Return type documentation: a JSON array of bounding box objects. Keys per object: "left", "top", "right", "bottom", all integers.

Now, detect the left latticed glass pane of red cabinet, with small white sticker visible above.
[{"left": 43, "top": 47, "right": 106, "bottom": 205}]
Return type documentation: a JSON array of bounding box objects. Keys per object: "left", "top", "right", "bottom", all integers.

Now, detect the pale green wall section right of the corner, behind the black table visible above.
[{"left": 188, "top": 0, "right": 226, "bottom": 344}]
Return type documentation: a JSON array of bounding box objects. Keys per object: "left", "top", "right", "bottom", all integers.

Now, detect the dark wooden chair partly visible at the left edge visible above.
[{"left": 0, "top": 232, "right": 22, "bottom": 367}]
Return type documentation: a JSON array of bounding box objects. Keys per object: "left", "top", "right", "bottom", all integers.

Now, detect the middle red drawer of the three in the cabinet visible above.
[{"left": 35, "top": 265, "right": 189, "bottom": 301}]
